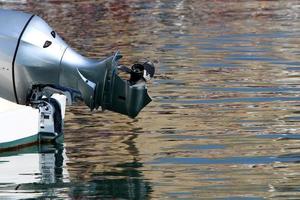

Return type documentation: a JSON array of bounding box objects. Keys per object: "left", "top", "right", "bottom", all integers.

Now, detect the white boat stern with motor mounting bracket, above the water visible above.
[{"left": 0, "top": 95, "right": 66, "bottom": 151}]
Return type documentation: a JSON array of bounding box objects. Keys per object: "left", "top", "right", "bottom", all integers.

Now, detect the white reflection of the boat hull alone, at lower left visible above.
[{"left": 0, "top": 145, "right": 69, "bottom": 199}]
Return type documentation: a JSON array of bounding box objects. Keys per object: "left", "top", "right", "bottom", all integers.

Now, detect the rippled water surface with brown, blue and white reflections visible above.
[{"left": 0, "top": 0, "right": 300, "bottom": 199}]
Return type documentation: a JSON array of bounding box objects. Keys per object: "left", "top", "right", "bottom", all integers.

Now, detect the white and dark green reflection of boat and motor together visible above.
[{"left": 0, "top": 145, "right": 152, "bottom": 199}]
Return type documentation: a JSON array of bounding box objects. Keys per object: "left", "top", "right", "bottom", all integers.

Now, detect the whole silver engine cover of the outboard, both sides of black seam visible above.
[{"left": 0, "top": 9, "right": 68, "bottom": 104}]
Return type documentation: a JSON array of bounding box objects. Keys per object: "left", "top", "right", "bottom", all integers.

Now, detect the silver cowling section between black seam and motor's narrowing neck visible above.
[{"left": 14, "top": 16, "right": 68, "bottom": 104}]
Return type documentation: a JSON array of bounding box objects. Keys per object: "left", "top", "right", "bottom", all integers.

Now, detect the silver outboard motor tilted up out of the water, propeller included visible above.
[{"left": 0, "top": 9, "right": 155, "bottom": 118}]
